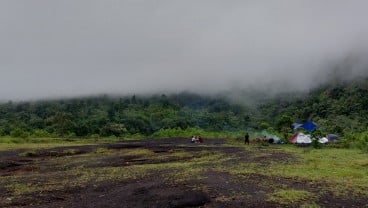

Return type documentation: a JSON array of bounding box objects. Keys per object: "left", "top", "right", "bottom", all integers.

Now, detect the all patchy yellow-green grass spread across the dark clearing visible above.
[{"left": 0, "top": 140, "right": 368, "bottom": 207}]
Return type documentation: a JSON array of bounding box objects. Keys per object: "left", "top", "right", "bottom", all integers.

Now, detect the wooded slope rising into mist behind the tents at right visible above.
[{"left": 259, "top": 79, "right": 368, "bottom": 136}]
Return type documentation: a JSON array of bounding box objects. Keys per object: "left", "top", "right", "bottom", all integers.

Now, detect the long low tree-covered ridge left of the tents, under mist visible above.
[{"left": 0, "top": 94, "right": 250, "bottom": 137}]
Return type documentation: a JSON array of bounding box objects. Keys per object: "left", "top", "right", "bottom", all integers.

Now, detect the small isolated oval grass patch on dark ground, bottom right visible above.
[{"left": 267, "top": 189, "right": 315, "bottom": 205}]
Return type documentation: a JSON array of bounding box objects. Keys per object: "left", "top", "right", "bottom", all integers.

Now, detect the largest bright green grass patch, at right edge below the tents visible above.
[{"left": 258, "top": 146, "right": 368, "bottom": 196}]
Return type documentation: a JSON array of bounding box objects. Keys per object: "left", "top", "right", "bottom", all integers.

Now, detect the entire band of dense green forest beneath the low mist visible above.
[{"left": 0, "top": 80, "right": 368, "bottom": 142}]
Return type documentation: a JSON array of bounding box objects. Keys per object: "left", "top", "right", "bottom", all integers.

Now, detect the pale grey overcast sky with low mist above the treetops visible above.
[{"left": 0, "top": 0, "right": 368, "bottom": 100}]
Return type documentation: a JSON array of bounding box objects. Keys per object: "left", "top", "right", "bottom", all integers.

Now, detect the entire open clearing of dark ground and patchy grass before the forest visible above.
[{"left": 0, "top": 138, "right": 368, "bottom": 208}]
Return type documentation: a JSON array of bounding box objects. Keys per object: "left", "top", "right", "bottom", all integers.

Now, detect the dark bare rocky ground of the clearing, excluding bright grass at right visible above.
[{"left": 0, "top": 138, "right": 368, "bottom": 208}]
